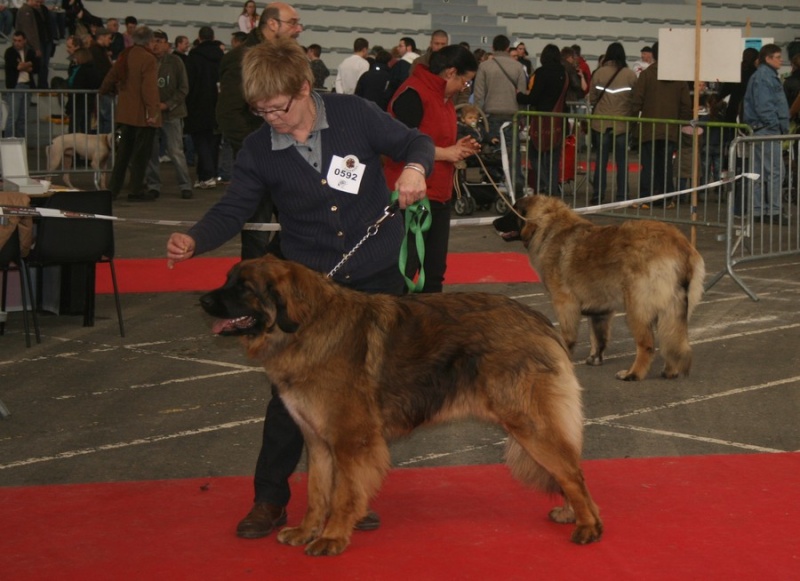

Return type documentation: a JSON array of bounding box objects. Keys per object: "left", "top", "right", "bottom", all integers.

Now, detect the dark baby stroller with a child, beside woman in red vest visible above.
[{"left": 453, "top": 105, "right": 509, "bottom": 216}]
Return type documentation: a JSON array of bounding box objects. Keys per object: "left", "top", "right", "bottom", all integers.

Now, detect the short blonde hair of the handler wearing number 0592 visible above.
[{"left": 242, "top": 38, "right": 314, "bottom": 105}]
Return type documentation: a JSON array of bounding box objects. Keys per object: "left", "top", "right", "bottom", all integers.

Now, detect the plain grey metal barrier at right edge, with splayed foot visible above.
[{"left": 706, "top": 135, "right": 800, "bottom": 301}]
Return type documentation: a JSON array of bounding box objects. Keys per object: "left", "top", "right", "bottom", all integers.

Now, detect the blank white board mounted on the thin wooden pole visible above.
[{"left": 658, "top": 28, "right": 742, "bottom": 83}]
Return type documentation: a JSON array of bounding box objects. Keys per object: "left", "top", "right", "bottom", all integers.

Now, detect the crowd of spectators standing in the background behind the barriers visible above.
[{"left": 0, "top": 0, "right": 800, "bottom": 208}]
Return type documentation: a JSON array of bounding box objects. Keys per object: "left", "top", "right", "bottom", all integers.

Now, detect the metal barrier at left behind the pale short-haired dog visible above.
[{"left": 0, "top": 89, "right": 115, "bottom": 187}]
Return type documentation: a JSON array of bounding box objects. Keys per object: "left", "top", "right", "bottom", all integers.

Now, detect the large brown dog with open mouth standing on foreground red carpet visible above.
[{"left": 200, "top": 257, "right": 602, "bottom": 555}]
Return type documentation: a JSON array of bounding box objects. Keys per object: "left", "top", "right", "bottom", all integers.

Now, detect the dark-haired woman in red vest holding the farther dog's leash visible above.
[{"left": 385, "top": 45, "right": 480, "bottom": 293}]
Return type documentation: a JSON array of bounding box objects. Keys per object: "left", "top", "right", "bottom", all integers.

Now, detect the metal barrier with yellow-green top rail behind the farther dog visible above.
[{"left": 510, "top": 111, "right": 750, "bottom": 228}]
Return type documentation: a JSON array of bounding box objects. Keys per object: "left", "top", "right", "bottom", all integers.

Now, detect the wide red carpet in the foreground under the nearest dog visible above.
[{"left": 0, "top": 454, "right": 800, "bottom": 581}]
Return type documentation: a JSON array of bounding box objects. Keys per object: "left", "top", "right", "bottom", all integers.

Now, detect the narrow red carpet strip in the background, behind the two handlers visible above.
[{"left": 96, "top": 252, "right": 539, "bottom": 293}]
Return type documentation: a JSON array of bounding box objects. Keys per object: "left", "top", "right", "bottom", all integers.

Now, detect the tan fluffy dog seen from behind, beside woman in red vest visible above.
[{"left": 495, "top": 196, "right": 705, "bottom": 381}]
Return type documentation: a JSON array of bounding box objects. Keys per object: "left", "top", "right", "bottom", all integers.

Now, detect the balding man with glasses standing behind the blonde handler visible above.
[{"left": 216, "top": 2, "right": 303, "bottom": 260}]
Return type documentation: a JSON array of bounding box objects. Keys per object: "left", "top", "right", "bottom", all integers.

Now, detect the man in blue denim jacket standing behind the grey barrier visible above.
[{"left": 743, "top": 44, "right": 789, "bottom": 224}]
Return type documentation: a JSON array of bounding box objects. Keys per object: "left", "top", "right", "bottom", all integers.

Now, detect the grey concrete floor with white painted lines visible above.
[{"left": 0, "top": 168, "right": 800, "bottom": 490}]
